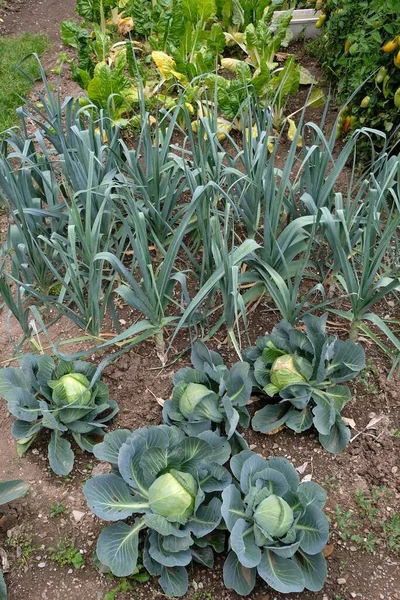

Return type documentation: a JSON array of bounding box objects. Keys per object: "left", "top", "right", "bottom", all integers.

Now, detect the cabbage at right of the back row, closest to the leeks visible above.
[{"left": 246, "top": 315, "right": 365, "bottom": 453}]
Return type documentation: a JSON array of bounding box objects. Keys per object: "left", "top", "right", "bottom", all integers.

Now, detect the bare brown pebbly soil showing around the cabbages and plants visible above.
[{"left": 0, "top": 0, "right": 400, "bottom": 600}]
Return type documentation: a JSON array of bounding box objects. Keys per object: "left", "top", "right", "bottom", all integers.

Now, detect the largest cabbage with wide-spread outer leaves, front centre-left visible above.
[{"left": 83, "top": 425, "right": 231, "bottom": 596}]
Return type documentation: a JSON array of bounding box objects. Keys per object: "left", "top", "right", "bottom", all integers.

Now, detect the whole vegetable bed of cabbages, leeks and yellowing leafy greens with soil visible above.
[{"left": 0, "top": 0, "right": 400, "bottom": 600}]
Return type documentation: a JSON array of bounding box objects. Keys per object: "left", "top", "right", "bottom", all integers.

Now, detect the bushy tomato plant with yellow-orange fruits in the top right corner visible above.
[{"left": 314, "top": 0, "right": 400, "bottom": 149}]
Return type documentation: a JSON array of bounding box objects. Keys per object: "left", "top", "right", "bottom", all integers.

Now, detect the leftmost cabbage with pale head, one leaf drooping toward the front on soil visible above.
[{"left": 0, "top": 354, "right": 118, "bottom": 475}]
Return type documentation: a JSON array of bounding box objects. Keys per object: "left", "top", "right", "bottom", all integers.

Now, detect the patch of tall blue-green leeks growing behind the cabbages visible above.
[{"left": 0, "top": 76, "right": 400, "bottom": 361}]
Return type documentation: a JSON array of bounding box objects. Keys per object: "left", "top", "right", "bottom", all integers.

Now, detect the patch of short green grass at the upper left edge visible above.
[{"left": 0, "top": 32, "right": 49, "bottom": 132}]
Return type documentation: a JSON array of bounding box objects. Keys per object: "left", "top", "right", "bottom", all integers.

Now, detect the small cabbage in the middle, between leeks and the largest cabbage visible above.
[{"left": 163, "top": 340, "right": 252, "bottom": 453}]
